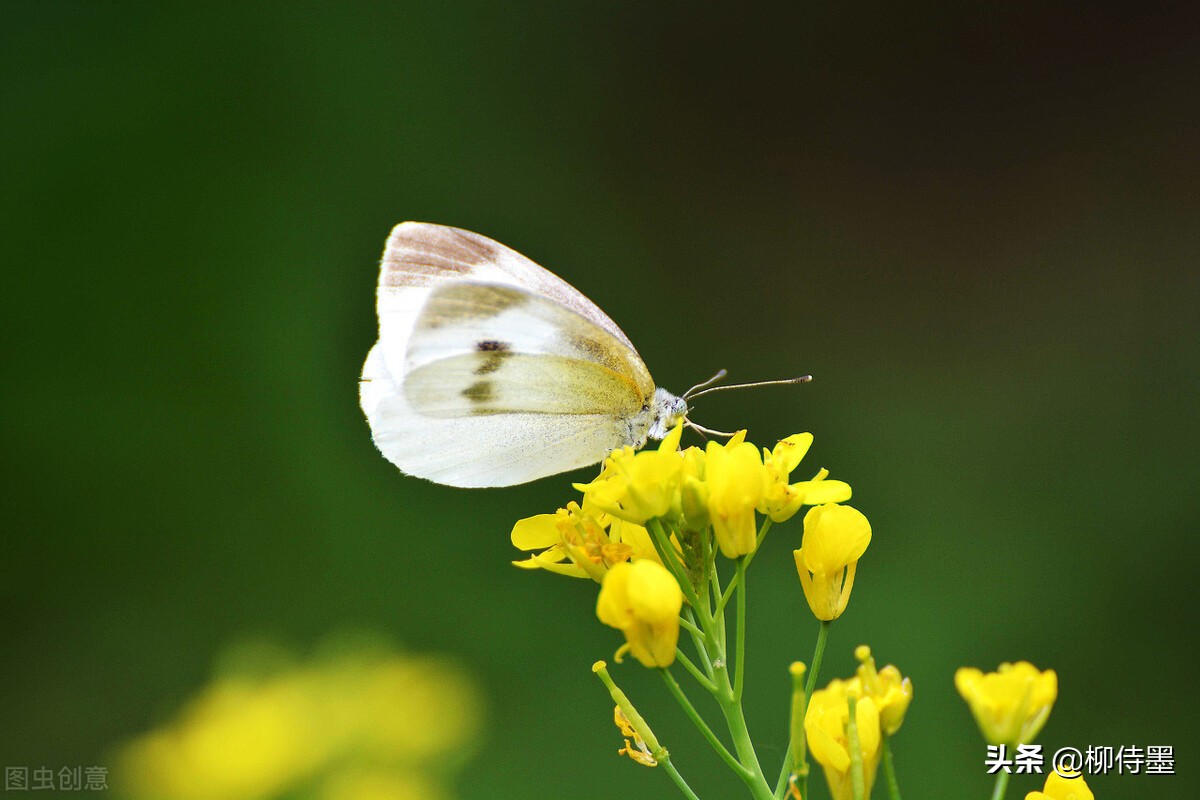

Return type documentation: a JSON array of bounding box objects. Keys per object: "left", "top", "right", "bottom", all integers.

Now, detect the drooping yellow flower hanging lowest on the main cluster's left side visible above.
[{"left": 596, "top": 560, "right": 683, "bottom": 667}]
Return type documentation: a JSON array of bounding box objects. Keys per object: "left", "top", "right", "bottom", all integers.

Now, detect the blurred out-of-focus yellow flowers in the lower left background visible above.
[{"left": 113, "top": 644, "right": 480, "bottom": 800}]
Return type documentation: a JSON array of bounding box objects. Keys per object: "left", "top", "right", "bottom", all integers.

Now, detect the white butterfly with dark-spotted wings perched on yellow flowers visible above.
[{"left": 359, "top": 222, "right": 798, "bottom": 487}]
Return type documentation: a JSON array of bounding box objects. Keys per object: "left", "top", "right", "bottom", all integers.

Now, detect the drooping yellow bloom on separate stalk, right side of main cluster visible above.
[{"left": 793, "top": 503, "right": 871, "bottom": 621}]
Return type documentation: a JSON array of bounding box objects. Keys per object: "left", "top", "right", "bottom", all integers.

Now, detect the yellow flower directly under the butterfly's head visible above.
[{"left": 574, "top": 425, "right": 683, "bottom": 525}]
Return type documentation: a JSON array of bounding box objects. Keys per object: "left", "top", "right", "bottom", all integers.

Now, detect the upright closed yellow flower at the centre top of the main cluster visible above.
[{"left": 704, "top": 432, "right": 766, "bottom": 559}]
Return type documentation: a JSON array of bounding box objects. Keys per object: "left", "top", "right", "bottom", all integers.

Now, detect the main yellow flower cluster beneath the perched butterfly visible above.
[{"left": 512, "top": 425, "right": 854, "bottom": 667}]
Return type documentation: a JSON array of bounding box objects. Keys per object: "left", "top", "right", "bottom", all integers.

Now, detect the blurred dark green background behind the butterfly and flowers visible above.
[{"left": 0, "top": 2, "right": 1200, "bottom": 800}]
